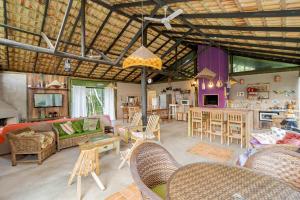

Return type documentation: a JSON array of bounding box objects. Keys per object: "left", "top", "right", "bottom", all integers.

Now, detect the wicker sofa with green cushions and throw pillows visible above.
[{"left": 52, "top": 116, "right": 105, "bottom": 151}]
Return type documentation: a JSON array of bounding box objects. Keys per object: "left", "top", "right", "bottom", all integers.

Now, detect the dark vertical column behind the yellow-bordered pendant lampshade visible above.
[{"left": 141, "top": 27, "right": 147, "bottom": 126}]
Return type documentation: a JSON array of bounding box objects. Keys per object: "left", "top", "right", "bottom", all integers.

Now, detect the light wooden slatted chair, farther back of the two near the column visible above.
[{"left": 116, "top": 112, "right": 142, "bottom": 143}]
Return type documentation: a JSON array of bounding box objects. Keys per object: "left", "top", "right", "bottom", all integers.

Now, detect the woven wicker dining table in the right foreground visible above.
[{"left": 167, "top": 163, "right": 300, "bottom": 200}]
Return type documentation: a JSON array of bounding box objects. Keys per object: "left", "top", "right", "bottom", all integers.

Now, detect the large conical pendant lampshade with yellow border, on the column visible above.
[{"left": 123, "top": 46, "right": 162, "bottom": 70}]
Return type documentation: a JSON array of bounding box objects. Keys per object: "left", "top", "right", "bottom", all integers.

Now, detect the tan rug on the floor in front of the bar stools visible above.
[{"left": 188, "top": 143, "right": 233, "bottom": 162}]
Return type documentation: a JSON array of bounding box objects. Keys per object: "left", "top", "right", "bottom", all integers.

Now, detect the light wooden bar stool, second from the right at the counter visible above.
[{"left": 209, "top": 111, "right": 226, "bottom": 144}]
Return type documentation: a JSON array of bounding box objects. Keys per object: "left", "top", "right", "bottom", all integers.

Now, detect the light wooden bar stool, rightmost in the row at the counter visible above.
[{"left": 227, "top": 113, "right": 245, "bottom": 148}]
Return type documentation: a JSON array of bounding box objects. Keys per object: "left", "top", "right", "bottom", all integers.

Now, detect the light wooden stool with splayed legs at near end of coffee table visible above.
[{"left": 68, "top": 147, "right": 105, "bottom": 199}]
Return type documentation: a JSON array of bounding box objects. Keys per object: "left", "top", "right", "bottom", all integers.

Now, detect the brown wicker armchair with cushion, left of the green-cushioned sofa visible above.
[{"left": 7, "top": 123, "right": 56, "bottom": 166}]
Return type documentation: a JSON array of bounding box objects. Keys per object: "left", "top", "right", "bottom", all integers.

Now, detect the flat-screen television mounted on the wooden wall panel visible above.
[{"left": 33, "top": 93, "right": 63, "bottom": 108}]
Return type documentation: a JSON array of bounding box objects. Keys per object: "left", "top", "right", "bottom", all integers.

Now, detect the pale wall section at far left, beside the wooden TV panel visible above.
[{"left": 0, "top": 72, "right": 27, "bottom": 118}]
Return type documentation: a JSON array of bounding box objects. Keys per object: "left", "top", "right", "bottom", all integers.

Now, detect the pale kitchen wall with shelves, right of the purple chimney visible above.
[{"left": 229, "top": 71, "right": 299, "bottom": 109}]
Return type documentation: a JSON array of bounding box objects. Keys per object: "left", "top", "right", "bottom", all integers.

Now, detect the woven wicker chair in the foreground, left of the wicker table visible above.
[{"left": 130, "top": 142, "right": 180, "bottom": 200}]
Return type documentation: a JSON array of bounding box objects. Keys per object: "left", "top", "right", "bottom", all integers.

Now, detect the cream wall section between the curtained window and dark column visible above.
[{"left": 117, "top": 82, "right": 141, "bottom": 119}]
